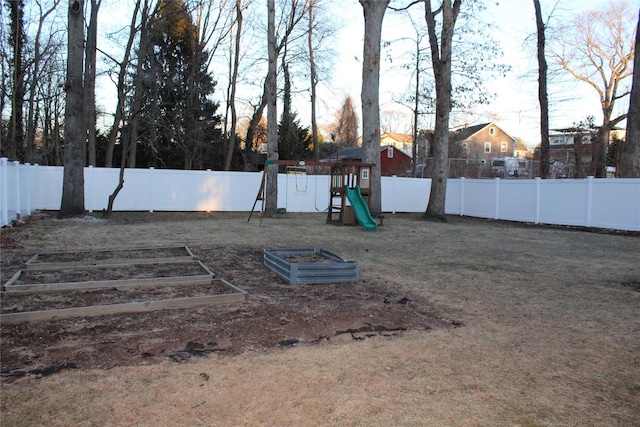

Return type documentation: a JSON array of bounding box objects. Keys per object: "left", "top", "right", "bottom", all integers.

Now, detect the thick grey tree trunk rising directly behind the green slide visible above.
[{"left": 360, "top": 0, "right": 389, "bottom": 215}]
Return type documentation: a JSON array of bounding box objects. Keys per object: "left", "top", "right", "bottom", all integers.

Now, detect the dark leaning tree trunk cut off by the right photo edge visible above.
[{"left": 618, "top": 8, "right": 640, "bottom": 178}]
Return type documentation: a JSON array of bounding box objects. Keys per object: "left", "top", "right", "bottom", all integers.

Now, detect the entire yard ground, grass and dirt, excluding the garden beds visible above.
[{"left": 0, "top": 212, "right": 640, "bottom": 426}]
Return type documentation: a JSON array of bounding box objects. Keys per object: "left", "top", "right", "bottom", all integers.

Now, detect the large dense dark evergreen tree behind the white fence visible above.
[{"left": 139, "top": 0, "right": 222, "bottom": 169}]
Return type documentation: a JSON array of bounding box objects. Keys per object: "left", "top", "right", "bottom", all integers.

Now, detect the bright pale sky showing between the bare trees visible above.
[{"left": 99, "top": 0, "right": 640, "bottom": 148}]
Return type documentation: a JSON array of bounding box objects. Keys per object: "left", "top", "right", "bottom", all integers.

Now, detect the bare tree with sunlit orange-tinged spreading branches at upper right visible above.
[{"left": 551, "top": 0, "right": 635, "bottom": 177}]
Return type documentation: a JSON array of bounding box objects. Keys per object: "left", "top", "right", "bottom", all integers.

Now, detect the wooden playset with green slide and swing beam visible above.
[{"left": 247, "top": 160, "right": 378, "bottom": 231}]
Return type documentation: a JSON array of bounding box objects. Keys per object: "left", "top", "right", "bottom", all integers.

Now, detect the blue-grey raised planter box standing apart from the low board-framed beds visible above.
[{"left": 264, "top": 248, "right": 360, "bottom": 285}]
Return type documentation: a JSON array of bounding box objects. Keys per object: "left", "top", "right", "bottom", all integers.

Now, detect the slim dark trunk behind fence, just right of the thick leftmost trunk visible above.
[{"left": 84, "top": 0, "right": 101, "bottom": 166}]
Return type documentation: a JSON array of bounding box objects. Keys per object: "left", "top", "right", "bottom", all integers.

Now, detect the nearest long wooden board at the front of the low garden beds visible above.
[{"left": 0, "top": 291, "right": 247, "bottom": 325}]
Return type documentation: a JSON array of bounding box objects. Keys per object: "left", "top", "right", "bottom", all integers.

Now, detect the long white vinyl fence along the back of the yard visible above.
[{"left": 0, "top": 158, "right": 640, "bottom": 231}]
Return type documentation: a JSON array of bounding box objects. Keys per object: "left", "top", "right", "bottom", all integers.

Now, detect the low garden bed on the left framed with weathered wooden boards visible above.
[{"left": 0, "top": 247, "right": 247, "bottom": 324}]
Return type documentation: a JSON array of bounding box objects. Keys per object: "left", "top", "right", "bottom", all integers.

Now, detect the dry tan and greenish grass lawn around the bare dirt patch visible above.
[{"left": 0, "top": 213, "right": 640, "bottom": 426}]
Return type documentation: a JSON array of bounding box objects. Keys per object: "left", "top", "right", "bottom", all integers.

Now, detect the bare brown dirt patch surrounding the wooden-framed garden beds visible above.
[{"left": 0, "top": 245, "right": 450, "bottom": 378}]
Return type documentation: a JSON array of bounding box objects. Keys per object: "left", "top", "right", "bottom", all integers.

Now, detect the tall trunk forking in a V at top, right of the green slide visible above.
[{"left": 422, "top": 0, "right": 461, "bottom": 222}]
